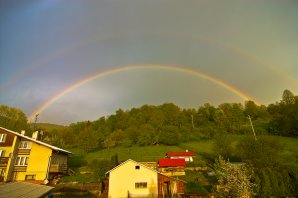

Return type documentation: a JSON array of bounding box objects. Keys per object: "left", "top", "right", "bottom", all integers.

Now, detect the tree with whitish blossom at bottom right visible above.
[{"left": 214, "top": 156, "right": 254, "bottom": 198}]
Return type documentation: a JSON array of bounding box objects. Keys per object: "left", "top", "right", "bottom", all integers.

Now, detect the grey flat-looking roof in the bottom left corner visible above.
[{"left": 0, "top": 182, "right": 54, "bottom": 198}]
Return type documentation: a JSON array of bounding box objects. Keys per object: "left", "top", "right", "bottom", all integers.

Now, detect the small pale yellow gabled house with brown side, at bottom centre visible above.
[{"left": 106, "top": 159, "right": 185, "bottom": 198}]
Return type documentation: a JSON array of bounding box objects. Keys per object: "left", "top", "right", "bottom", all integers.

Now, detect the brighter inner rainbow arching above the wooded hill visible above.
[{"left": 28, "top": 64, "right": 259, "bottom": 121}]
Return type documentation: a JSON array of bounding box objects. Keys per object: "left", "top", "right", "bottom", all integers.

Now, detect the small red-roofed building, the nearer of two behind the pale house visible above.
[{"left": 158, "top": 158, "right": 186, "bottom": 176}]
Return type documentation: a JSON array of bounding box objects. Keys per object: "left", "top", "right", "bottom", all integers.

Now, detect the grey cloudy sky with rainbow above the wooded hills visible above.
[{"left": 0, "top": 0, "right": 298, "bottom": 125}]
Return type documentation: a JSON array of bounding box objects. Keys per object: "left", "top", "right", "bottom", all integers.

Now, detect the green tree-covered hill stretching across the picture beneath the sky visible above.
[{"left": 0, "top": 90, "right": 298, "bottom": 151}]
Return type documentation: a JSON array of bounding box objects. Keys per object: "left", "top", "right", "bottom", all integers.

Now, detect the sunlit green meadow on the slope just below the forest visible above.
[{"left": 69, "top": 135, "right": 298, "bottom": 164}]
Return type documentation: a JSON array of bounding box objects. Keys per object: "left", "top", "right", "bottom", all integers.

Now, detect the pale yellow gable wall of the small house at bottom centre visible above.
[{"left": 108, "top": 161, "right": 158, "bottom": 198}]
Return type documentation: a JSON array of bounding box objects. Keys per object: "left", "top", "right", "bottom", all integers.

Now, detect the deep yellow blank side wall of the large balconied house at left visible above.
[{"left": 14, "top": 142, "right": 52, "bottom": 181}]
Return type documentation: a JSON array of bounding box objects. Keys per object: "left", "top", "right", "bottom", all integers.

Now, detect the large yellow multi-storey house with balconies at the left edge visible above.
[{"left": 0, "top": 127, "right": 71, "bottom": 183}]
